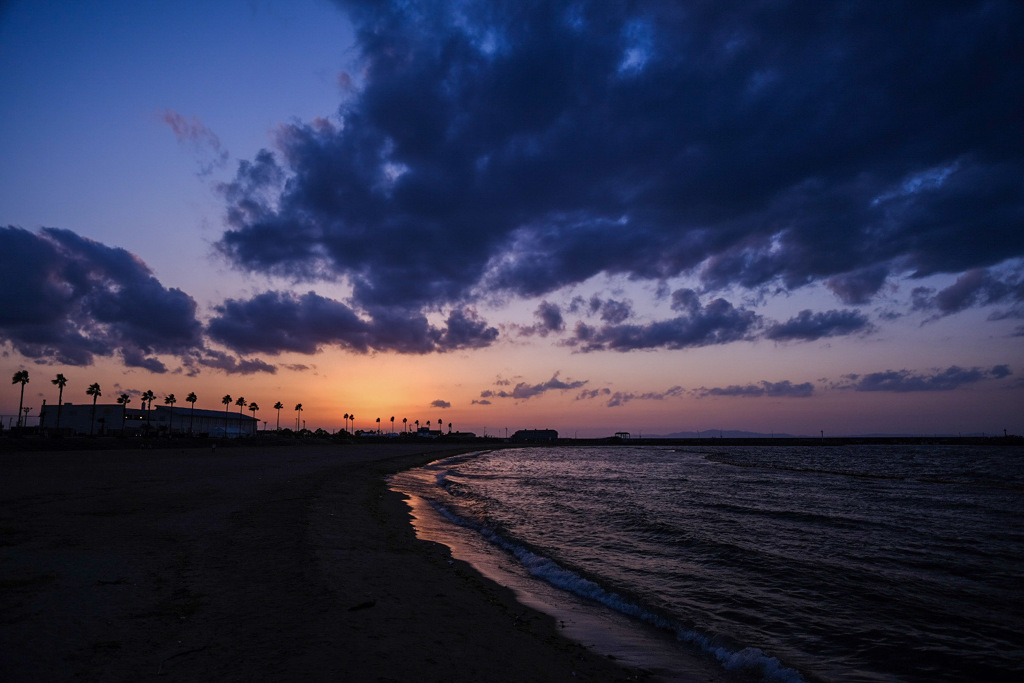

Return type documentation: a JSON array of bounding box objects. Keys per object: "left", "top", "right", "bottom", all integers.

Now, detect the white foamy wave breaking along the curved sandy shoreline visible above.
[{"left": 429, "top": 497, "right": 804, "bottom": 683}]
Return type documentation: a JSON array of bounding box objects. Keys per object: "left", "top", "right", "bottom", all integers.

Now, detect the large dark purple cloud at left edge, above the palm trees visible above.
[{"left": 0, "top": 226, "right": 203, "bottom": 373}]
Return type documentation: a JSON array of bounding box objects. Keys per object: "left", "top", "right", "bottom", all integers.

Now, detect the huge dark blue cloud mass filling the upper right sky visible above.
[{"left": 211, "top": 0, "right": 1024, "bottom": 315}]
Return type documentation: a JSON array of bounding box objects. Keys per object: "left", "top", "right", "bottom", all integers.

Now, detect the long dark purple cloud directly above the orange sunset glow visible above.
[{"left": 207, "top": 291, "right": 498, "bottom": 354}]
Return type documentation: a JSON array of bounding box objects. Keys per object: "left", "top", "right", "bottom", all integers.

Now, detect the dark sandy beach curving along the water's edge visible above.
[{"left": 0, "top": 444, "right": 644, "bottom": 681}]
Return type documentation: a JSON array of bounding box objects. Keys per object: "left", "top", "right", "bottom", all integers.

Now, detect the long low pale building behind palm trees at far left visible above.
[{"left": 39, "top": 403, "right": 259, "bottom": 438}]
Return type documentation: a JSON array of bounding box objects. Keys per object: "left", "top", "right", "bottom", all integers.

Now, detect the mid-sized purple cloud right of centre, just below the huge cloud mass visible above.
[{"left": 567, "top": 290, "right": 760, "bottom": 351}]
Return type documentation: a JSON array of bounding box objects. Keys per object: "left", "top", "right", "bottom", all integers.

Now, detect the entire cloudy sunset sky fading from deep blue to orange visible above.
[{"left": 0, "top": 0, "right": 1024, "bottom": 437}]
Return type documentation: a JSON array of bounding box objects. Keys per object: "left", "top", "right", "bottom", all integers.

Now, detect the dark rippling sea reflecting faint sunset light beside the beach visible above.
[{"left": 390, "top": 445, "right": 1024, "bottom": 683}]
